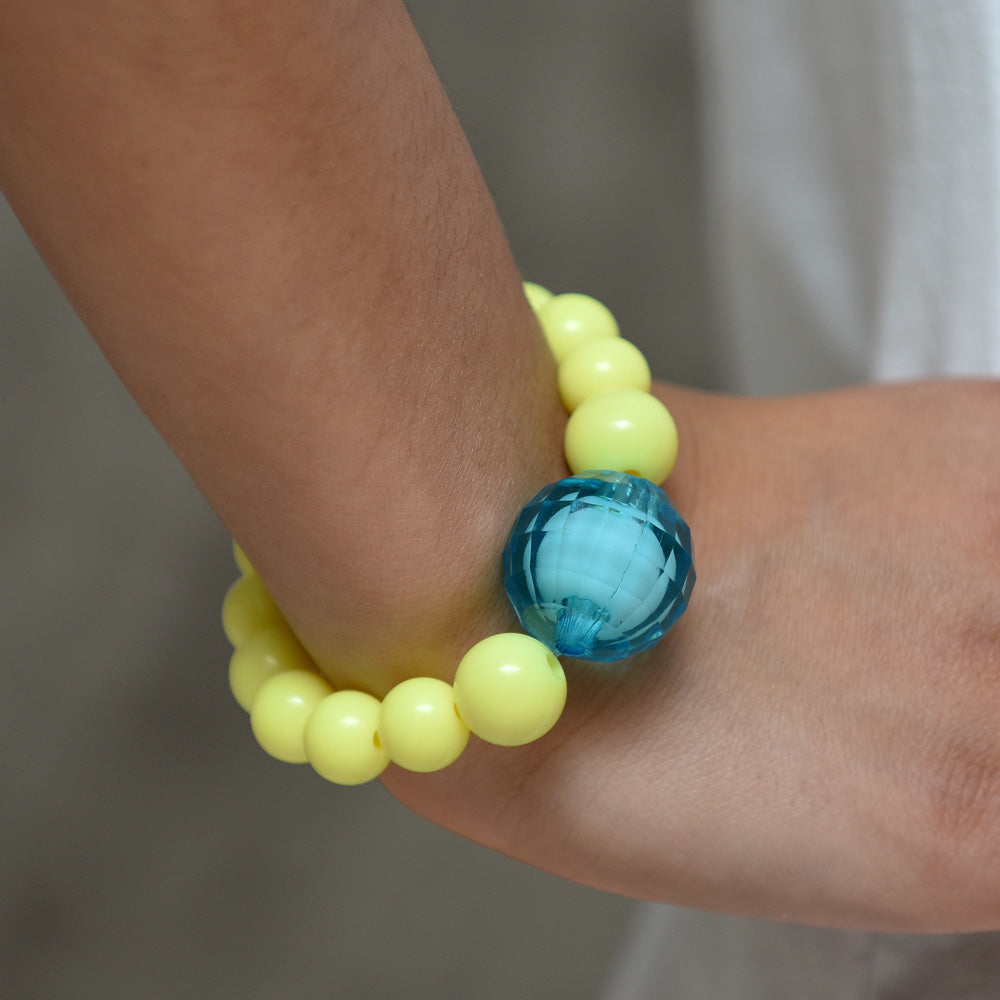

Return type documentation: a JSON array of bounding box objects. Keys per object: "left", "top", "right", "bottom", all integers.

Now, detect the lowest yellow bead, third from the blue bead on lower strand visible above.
[{"left": 305, "top": 691, "right": 389, "bottom": 785}]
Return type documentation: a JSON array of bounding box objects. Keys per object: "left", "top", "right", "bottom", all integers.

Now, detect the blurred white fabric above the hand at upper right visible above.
[{"left": 696, "top": 0, "right": 1000, "bottom": 392}]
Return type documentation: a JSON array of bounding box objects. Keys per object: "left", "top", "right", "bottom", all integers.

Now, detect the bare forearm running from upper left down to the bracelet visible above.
[{"left": 0, "top": 0, "right": 561, "bottom": 688}]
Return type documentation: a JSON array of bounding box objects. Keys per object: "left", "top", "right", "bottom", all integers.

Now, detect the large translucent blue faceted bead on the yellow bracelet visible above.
[{"left": 503, "top": 472, "right": 695, "bottom": 661}]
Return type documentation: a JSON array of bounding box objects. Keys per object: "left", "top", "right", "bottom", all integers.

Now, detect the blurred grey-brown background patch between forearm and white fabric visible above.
[{"left": 408, "top": 0, "right": 723, "bottom": 386}]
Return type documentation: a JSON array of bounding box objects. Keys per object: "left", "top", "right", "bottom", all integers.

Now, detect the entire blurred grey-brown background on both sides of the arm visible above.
[{"left": 0, "top": 0, "right": 719, "bottom": 1000}]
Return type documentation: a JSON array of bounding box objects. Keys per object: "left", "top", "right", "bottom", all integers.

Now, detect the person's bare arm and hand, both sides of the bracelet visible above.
[{"left": 0, "top": 0, "right": 1000, "bottom": 931}]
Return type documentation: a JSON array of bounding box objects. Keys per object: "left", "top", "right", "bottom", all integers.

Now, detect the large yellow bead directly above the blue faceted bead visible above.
[{"left": 566, "top": 389, "right": 677, "bottom": 483}]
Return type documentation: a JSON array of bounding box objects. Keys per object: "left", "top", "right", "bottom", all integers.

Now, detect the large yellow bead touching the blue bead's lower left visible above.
[{"left": 455, "top": 632, "right": 566, "bottom": 747}]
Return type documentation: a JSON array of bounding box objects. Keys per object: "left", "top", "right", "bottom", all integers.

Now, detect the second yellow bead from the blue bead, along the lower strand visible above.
[{"left": 378, "top": 677, "right": 469, "bottom": 771}]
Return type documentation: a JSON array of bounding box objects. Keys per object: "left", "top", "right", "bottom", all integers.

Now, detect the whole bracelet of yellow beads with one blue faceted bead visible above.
[{"left": 222, "top": 282, "right": 695, "bottom": 785}]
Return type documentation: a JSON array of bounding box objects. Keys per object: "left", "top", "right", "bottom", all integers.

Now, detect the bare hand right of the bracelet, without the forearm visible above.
[{"left": 386, "top": 382, "right": 1000, "bottom": 931}]
